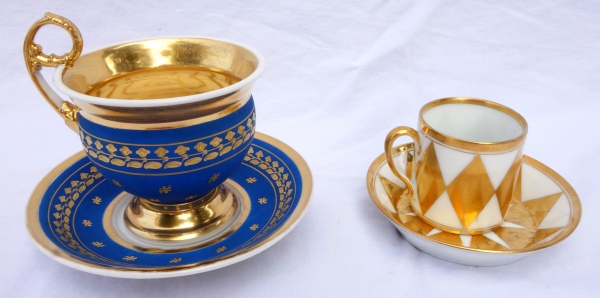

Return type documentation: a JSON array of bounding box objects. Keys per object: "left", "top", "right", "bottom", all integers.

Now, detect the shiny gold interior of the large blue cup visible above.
[{"left": 62, "top": 38, "right": 258, "bottom": 99}]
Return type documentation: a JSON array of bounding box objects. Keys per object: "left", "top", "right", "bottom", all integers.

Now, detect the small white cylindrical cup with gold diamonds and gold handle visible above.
[{"left": 385, "top": 97, "right": 527, "bottom": 235}]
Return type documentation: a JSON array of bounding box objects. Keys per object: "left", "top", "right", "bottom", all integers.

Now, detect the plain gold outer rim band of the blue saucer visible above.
[{"left": 26, "top": 132, "right": 313, "bottom": 277}]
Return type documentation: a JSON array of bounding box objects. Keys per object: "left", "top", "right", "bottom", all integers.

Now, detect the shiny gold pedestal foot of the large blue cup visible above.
[{"left": 124, "top": 185, "right": 240, "bottom": 241}]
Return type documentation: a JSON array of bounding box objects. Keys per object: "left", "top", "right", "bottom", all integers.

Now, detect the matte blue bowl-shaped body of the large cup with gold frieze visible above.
[{"left": 78, "top": 98, "right": 256, "bottom": 204}]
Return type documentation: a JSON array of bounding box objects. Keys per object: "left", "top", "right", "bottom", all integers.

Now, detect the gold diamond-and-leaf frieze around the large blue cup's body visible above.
[{"left": 79, "top": 112, "right": 256, "bottom": 170}]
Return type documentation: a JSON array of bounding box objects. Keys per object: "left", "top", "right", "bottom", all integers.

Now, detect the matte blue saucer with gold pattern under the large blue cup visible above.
[{"left": 27, "top": 132, "right": 312, "bottom": 278}]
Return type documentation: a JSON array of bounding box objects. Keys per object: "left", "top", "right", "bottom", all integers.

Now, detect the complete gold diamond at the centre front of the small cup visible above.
[{"left": 448, "top": 155, "right": 494, "bottom": 227}]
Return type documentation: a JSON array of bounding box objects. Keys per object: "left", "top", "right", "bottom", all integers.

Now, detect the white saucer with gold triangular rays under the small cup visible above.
[{"left": 367, "top": 143, "right": 581, "bottom": 266}]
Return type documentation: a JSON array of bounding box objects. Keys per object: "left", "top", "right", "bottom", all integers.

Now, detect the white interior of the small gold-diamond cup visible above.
[{"left": 423, "top": 103, "right": 524, "bottom": 143}]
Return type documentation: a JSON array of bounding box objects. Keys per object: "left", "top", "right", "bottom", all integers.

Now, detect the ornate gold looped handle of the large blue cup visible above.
[{"left": 23, "top": 12, "right": 83, "bottom": 132}]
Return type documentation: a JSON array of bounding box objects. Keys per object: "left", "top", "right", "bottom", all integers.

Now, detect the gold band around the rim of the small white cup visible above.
[{"left": 419, "top": 97, "right": 528, "bottom": 152}]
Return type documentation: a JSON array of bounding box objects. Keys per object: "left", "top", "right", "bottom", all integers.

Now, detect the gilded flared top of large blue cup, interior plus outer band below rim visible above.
[{"left": 62, "top": 38, "right": 259, "bottom": 123}]
